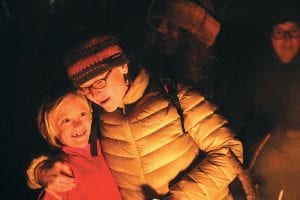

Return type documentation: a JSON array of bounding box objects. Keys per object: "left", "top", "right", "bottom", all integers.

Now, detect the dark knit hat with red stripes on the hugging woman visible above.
[{"left": 65, "top": 35, "right": 129, "bottom": 87}]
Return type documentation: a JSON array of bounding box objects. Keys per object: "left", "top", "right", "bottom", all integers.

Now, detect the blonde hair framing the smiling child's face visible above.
[{"left": 37, "top": 91, "right": 92, "bottom": 148}]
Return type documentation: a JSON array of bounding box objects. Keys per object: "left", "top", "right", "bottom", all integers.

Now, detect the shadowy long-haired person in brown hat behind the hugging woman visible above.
[{"left": 143, "top": 0, "right": 220, "bottom": 99}]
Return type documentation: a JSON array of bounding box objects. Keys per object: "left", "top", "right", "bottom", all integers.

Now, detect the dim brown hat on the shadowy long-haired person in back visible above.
[{"left": 150, "top": 0, "right": 221, "bottom": 47}]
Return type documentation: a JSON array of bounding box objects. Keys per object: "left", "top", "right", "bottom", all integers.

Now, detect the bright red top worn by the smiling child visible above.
[{"left": 40, "top": 142, "right": 122, "bottom": 200}]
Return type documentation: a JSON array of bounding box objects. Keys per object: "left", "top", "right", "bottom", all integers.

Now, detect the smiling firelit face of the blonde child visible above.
[{"left": 52, "top": 95, "right": 92, "bottom": 148}]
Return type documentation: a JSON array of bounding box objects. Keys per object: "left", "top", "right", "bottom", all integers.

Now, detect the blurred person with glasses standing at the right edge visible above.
[{"left": 254, "top": 4, "right": 300, "bottom": 200}]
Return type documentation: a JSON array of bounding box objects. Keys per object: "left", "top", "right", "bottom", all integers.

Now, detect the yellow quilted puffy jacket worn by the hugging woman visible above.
[{"left": 100, "top": 71, "right": 242, "bottom": 200}]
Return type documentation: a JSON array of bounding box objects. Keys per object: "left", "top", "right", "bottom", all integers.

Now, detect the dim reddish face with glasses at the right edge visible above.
[{"left": 271, "top": 21, "right": 300, "bottom": 64}]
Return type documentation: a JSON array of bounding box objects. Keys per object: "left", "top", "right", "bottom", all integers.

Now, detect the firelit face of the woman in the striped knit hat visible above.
[{"left": 80, "top": 64, "right": 128, "bottom": 112}]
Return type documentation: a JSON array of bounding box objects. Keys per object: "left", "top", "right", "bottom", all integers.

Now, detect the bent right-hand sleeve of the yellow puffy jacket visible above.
[{"left": 170, "top": 85, "right": 243, "bottom": 200}]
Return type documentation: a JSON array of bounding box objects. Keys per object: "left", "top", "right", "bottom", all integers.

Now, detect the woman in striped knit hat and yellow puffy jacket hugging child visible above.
[{"left": 28, "top": 35, "right": 243, "bottom": 200}]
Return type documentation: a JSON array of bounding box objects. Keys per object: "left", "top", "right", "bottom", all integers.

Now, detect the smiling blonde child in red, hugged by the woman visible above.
[{"left": 34, "top": 92, "right": 121, "bottom": 200}]
